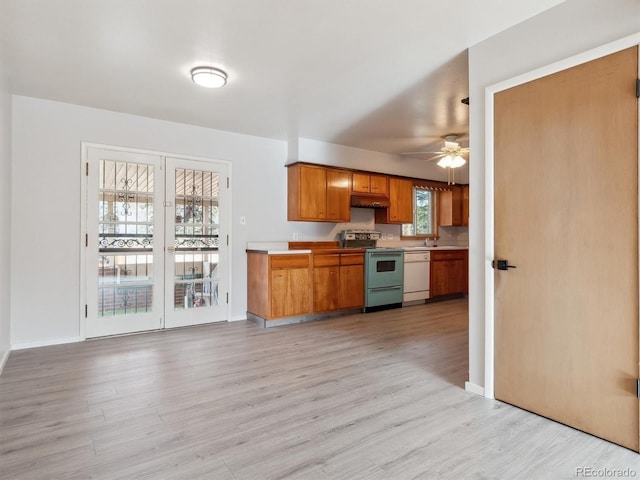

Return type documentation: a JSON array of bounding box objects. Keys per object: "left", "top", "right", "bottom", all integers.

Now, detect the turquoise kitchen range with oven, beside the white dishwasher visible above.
[{"left": 340, "top": 230, "right": 404, "bottom": 312}]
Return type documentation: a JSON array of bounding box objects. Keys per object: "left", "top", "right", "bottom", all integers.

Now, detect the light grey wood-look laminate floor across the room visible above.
[{"left": 0, "top": 299, "right": 640, "bottom": 480}]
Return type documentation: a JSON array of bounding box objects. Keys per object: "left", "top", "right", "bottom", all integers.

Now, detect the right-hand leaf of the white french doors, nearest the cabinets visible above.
[{"left": 164, "top": 158, "right": 229, "bottom": 328}]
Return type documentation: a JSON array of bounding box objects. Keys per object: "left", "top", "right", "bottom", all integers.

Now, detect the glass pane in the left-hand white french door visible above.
[{"left": 97, "top": 160, "right": 154, "bottom": 317}]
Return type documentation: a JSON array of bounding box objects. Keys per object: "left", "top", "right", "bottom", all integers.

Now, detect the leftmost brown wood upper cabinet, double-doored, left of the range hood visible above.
[{"left": 287, "top": 163, "right": 351, "bottom": 223}]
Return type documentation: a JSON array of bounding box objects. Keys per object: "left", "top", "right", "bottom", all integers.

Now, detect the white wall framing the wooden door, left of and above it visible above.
[{"left": 469, "top": 0, "right": 640, "bottom": 392}]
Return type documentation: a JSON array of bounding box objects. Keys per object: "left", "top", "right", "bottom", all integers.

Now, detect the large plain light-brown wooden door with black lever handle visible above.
[{"left": 494, "top": 47, "right": 639, "bottom": 451}]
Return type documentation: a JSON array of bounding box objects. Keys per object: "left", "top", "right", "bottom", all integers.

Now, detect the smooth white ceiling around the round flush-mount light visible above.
[{"left": 0, "top": 0, "right": 561, "bottom": 154}]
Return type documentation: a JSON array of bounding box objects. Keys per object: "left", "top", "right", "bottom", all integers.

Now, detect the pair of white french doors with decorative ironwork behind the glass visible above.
[{"left": 84, "top": 147, "right": 229, "bottom": 338}]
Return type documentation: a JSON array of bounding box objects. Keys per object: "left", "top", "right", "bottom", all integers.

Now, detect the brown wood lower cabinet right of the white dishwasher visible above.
[{"left": 429, "top": 250, "right": 469, "bottom": 298}]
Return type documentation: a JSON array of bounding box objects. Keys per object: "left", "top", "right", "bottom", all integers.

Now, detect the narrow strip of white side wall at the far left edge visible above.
[{"left": 0, "top": 61, "right": 11, "bottom": 373}]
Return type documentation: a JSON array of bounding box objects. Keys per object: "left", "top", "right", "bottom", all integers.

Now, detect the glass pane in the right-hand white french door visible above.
[{"left": 173, "top": 168, "right": 219, "bottom": 310}]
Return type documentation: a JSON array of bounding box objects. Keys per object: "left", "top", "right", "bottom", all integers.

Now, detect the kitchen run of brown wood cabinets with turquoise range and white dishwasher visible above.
[{"left": 247, "top": 162, "right": 469, "bottom": 327}]
